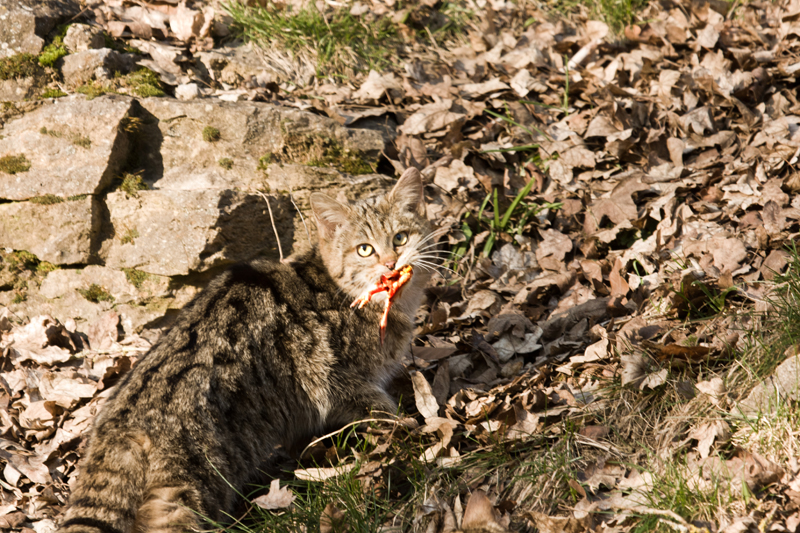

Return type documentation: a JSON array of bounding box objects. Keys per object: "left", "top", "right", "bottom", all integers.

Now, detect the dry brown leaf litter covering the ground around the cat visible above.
[{"left": 0, "top": 0, "right": 800, "bottom": 533}]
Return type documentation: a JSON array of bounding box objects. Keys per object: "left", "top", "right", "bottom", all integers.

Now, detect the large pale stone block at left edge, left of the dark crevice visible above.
[{"left": 0, "top": 95, "right": 131, "bottom": 200}]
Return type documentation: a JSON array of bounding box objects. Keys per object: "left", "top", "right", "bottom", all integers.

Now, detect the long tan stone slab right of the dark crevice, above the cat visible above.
[{"left": 135, "top": 98, "right": 384, "bottom": 190}]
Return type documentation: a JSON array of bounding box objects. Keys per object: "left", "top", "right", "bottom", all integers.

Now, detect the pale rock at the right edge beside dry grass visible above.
[{"left": 731, "top": 354, "right": 800, "bottom": 417}]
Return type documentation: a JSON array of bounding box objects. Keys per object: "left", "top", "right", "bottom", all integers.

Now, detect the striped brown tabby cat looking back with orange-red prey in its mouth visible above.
[{"left": 59, "top": 169, "right": 434, "bottom": 533}]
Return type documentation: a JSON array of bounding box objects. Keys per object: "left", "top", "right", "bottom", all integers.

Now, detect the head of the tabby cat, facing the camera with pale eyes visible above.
[{"left": 311, "top": 168, "right": 434, "bottom": 306}]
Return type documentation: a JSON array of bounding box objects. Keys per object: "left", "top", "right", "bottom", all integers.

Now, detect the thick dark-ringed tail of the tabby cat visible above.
[{"left": 58, "top": 429, "right": 150, "bottom": 533}]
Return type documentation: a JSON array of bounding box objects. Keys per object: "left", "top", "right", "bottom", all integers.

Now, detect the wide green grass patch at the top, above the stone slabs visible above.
[{"left": 224, "top": 2, "right": 398, "bottom": 77}]
